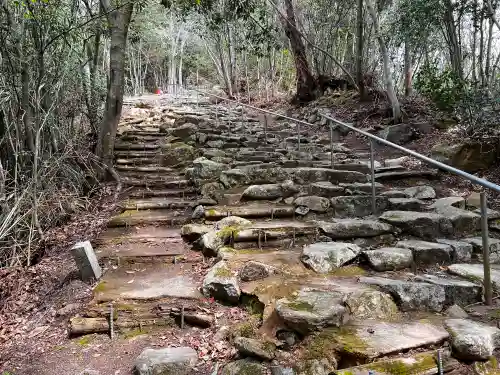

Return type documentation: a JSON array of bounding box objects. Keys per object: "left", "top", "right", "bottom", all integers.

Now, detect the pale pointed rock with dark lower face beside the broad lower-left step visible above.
[{"left": 202, "top": 261, "right": 241, "bottom": 304}]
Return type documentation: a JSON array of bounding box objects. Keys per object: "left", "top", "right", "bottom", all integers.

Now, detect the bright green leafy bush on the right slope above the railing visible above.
[{"left": 415, "top": 63, "right": 465, "bottom": 111}]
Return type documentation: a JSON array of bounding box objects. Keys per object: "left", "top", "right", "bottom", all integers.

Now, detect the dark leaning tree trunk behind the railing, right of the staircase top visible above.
[{"left": 282, "top": 0, "right": 316, "bottom": 102}]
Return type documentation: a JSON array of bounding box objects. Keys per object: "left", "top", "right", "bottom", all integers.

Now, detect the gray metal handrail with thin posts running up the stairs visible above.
[{"left": 157, "top": 87, "right": 500, "bottom": 305}]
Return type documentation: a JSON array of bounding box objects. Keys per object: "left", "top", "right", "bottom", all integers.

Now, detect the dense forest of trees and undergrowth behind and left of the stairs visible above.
[{"left": 0, "top": 0, "right": 500, "bottom": 266}]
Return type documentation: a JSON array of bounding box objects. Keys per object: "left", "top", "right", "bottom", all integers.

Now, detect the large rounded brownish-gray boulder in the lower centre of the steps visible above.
[{"left": 276, "top": 288, "right": 348, "bottom": 335}]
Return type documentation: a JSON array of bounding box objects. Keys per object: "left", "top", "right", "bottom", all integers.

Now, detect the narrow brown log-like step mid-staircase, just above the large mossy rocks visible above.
[{"left": 204, "top": 204, "right": 295, "bottom": 220}]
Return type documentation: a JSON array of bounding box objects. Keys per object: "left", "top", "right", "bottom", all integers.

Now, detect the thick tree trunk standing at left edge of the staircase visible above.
[{"left": 96, "top": 0, "right": 134, "bottom": 176}]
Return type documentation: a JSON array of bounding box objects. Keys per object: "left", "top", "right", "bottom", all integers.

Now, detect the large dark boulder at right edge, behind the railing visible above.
[{"left": 432, "top": 141, "right": 499, "bottom": 172}]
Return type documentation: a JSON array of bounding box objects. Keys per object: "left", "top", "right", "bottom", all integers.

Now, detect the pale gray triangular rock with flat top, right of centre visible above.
[{"left": 300, "top": 242, "right": 361, "bottom": 273}]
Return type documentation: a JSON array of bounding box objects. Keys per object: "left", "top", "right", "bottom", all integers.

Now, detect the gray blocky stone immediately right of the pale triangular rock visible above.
[{"left": 363, "top": 247, "right": 413, "bottom": 272}]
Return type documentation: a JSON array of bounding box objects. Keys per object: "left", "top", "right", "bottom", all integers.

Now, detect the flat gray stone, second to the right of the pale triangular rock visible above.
[{"left": 396, "top": 240, "right": 453, "bottom": 265}]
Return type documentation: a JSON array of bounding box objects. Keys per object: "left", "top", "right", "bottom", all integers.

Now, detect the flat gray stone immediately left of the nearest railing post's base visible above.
[{"left": 416, "top": 274, "right": 482, "bottom": 306}]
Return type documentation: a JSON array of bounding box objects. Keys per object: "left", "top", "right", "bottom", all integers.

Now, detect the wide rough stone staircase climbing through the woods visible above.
[{"left": 71, "top": 92, "right": 500, "bottom": 375}]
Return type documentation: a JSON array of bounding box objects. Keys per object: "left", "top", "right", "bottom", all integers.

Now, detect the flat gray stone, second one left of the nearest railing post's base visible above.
[{"left": 359, "top": 277, "right": 446, "bottom": 312}]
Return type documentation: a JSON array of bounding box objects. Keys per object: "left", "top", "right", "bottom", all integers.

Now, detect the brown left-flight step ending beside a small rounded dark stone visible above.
[{"left": 108, "top": 210, "right": 191, "bottom": 227}]
